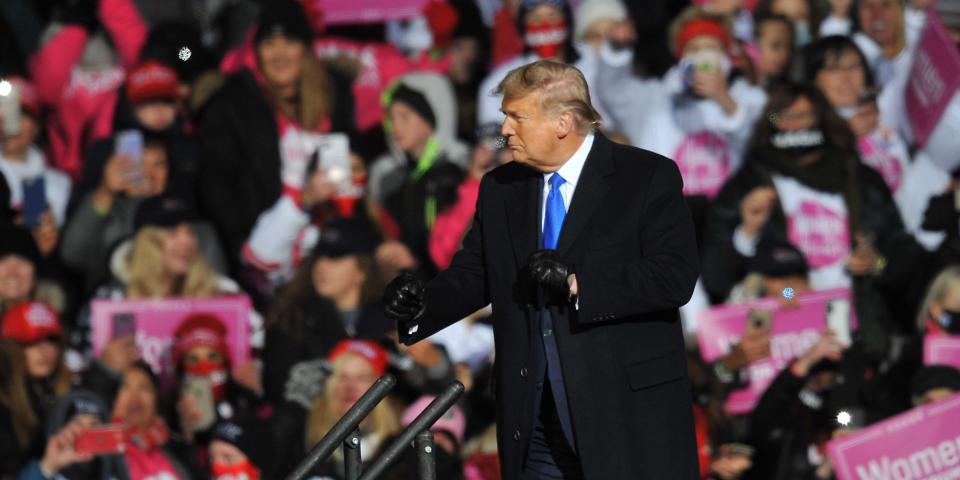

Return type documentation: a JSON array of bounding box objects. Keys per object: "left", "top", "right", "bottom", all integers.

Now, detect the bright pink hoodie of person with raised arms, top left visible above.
[{"left": 30, "top": 0, "right": 147, "bottom": 180}]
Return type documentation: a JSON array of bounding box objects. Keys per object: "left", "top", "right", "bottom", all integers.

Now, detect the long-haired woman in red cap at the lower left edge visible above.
[{"left": 0, "top": 302, "right": 72, "bottom": 478}]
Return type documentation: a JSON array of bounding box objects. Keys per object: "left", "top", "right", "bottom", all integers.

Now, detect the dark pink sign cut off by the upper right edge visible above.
[{"left": 904, "top": 12, "right": 960, "bottom": 146}]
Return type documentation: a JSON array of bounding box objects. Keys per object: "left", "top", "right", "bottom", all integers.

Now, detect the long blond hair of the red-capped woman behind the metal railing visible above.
[{"left": 305, "top": 352, "right": 400, "bottom": 454}]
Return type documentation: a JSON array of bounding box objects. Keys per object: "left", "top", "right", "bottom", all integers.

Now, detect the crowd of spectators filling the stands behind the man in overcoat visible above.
[{"left": 0, "top": 0, "right": 960, "bottom": 480}]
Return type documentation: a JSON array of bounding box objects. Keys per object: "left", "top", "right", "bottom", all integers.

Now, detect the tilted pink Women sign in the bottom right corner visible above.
[{"left": 827, "top": 395, "right": 960, "bottom": 480}]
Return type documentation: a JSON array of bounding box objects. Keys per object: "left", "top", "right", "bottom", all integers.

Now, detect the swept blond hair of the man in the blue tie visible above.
[{"left": 493, "top": 60, "right": 602, "bottom": 133}]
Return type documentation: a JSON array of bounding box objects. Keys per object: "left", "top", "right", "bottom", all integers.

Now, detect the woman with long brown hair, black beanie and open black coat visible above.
[{"left": 199, "top": 0, "right": 355, "bottom": 280}]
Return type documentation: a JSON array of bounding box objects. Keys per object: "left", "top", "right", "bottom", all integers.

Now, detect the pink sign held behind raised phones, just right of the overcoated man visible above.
[{"left": 697, "top": 288, "right": 857, "bottom": 414}]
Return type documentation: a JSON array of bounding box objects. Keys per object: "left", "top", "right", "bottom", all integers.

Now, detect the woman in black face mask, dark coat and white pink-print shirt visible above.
[{"left": 702, "top": 85, "right": 919, "bottom": 358}]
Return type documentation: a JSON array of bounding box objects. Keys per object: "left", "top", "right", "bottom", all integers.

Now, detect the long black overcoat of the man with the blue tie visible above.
[{"left": 401, "top": 133, "right": 699, "bottom": 480}]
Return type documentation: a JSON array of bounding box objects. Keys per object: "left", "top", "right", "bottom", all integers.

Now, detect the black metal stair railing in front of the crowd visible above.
[{"left": 287, "top": 373, "right": 464, "bottom": 480}]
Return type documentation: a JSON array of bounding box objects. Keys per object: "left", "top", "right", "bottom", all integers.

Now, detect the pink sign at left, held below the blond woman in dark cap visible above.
[{"left": 90, "top": 296, "right": 251, "bottom": 387}]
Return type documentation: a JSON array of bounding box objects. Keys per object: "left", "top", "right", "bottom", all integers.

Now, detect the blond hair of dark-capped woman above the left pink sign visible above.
[{"left": 126, "top": 227, "right": 222, "bottom": 299}]
